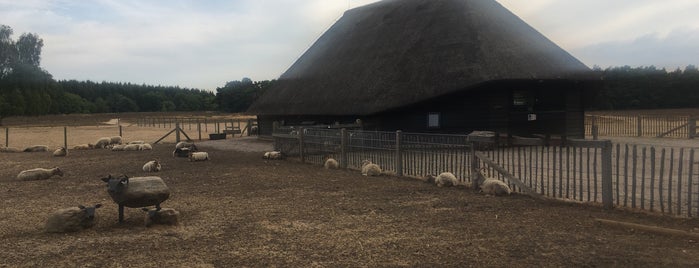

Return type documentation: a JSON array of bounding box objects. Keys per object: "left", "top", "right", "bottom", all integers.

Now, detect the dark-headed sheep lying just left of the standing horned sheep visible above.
[{"left": 45, "top": 204, "right": 102, "bottom": 233}]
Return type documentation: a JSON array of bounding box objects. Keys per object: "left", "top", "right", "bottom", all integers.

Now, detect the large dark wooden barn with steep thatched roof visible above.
[{"left": 248, "top": 0, "right": 599, "bottom": 137}]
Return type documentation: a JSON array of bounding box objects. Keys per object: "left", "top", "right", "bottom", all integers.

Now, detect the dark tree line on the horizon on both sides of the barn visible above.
[{"left": 0, "top": 25, "right": 699, "bottom": 124}]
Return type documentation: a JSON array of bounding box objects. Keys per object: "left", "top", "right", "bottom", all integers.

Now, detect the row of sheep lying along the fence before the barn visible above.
[{"left": 262, "top": 151, "right": 512, "bottom": 196}]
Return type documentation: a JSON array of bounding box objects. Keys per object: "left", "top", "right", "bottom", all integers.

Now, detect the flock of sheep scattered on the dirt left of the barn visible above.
[{"left": 9, "top": 136, "right": 209, "bottom": 233}]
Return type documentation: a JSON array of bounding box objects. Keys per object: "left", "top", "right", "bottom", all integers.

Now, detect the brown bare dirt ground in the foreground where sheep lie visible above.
[{"left": 0, "top": 114, "right": 699, "bottom": 267}]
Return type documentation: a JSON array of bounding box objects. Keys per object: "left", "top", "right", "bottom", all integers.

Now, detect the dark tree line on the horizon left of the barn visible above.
[{"left": 0, "top": 25, "right": 273, "bottom": 123}]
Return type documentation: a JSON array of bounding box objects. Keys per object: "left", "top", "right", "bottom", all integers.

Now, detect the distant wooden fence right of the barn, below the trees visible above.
[{"left": 585, "top": 114, "right": 697, "bottom": 139}]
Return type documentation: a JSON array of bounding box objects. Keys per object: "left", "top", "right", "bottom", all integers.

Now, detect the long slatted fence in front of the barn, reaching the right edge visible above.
[{"left": 273, "top": 128, "right": 699, "bottom": 217}]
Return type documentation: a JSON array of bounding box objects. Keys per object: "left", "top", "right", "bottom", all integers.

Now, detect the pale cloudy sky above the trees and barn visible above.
[{"left": 0, "top": 0, "right": 699, "bottom": 90}]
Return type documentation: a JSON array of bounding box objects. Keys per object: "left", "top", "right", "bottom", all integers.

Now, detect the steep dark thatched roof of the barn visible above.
[{"left": 249, "top": 0, "right": 590, "bottom": 115}]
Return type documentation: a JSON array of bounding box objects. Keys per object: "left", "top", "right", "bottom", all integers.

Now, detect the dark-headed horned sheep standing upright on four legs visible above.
[{"left": 102, "top": 175, "right": 170, "bottom": 222}]
